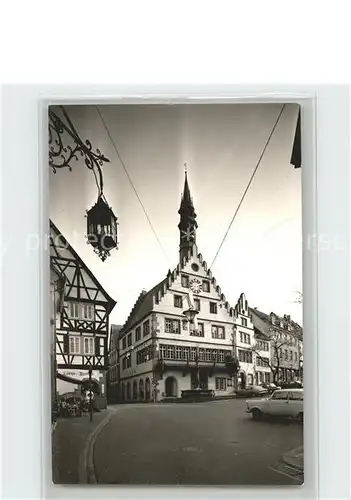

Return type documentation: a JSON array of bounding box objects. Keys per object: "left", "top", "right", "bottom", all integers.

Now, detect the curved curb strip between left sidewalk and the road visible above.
[{"left": 78, "top": 409, "right": 116, "bottom": 484}]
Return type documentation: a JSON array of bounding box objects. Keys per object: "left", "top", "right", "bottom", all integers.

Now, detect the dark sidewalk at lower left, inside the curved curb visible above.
[{"left": 52, "top": 410, "right": 108, "bottom": 484}]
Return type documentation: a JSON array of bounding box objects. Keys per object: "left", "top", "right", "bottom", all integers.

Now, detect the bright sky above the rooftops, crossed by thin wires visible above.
[{"left": 50, "top": 104, "right": 302, "bottom": 324}]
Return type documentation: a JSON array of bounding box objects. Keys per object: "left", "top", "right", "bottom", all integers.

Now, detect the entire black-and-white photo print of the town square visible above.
[{"left": 47, "top": 102, "right": 307, "bottom": 486}]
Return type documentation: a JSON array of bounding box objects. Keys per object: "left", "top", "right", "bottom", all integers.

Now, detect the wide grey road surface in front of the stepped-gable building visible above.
[{"left": 93, "top": 400, "right": 303, "bottom": 486}]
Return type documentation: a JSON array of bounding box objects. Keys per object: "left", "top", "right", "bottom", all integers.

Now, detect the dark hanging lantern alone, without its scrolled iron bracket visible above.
[{"left": 87, "top": 196, "right": 118, "bottom": 261}]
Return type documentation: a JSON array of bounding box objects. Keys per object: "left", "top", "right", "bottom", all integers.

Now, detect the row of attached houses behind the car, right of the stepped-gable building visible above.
[{"left": 250, "top": 309, "right": 303, "bottom": 382}]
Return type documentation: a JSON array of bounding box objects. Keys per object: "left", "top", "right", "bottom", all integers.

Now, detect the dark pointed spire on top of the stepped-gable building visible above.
[{"left": 178, "top": 167, "right": 198, "bottom": 262}]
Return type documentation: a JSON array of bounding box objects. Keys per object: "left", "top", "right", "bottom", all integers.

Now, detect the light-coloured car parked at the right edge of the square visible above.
[{"left": 246, "top": 389, "right": 303, "bottom": 422}]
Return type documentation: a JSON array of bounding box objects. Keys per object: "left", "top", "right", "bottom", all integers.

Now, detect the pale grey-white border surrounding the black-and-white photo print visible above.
[{"left": 0, "top": 85, "right": 351, "bottom": 499}]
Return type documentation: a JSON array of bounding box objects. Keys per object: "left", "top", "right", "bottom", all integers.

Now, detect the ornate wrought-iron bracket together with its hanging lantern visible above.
[{"left": 49, "top": 106, "right": 118, "bottom": 262}]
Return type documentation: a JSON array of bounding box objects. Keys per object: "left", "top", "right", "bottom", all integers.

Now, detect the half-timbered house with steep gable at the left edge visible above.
[{"left": 50, "top": 222, "right": 115, "bottom": 407}]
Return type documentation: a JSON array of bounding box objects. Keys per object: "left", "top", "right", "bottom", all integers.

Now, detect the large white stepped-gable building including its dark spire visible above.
[{"left": 118, "top": 173, "right": 254, "bottom": 401}]
